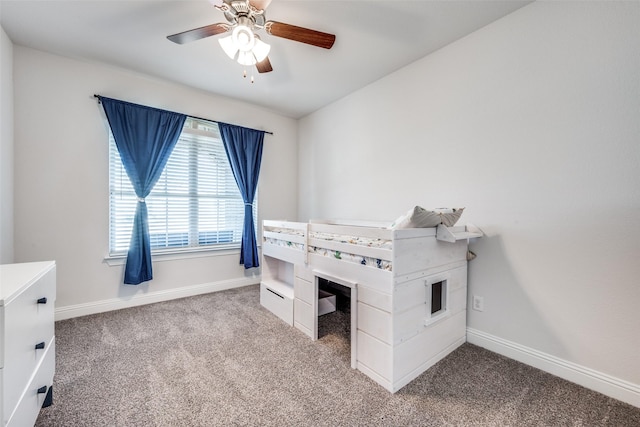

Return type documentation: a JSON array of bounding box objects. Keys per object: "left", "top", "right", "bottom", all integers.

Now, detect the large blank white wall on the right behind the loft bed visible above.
[{"left": 299, "top": 2, "right": 640, "bottom": 406}]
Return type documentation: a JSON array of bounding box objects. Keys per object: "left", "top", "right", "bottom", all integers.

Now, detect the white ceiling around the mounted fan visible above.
[{"left": 0, "top": 0, "right": 531, "bottom": 118}]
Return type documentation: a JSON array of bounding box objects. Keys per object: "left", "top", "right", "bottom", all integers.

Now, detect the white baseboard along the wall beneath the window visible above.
[{"left": 55, "top": 277, "right": 260, "bottom": 321}]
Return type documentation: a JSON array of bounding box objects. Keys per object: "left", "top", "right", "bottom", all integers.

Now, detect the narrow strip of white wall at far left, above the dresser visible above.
[{"left": 0, "top": 27, "right": 13, "bottom": 264}]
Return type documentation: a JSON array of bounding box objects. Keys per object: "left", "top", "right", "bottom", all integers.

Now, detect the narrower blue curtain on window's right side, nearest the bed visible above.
[{"left": 218, "top": 123, "right": 264, "bottom": 268}]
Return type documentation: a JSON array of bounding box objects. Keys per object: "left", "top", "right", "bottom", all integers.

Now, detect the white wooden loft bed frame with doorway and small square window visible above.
[{"left": 260, "top": 221, "right": 482, "bottom": 393}]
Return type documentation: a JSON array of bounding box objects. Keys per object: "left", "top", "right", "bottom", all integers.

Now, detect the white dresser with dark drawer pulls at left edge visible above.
[{"left": 0, "top": 261, "right": 56, "bottom": 427}]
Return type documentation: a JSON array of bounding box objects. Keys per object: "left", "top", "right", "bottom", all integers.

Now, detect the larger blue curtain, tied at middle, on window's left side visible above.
[{"left": 99, "top": 96, "right": 187, "bottom": 285}]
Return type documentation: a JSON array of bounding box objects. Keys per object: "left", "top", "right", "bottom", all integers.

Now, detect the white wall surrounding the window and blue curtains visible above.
[{"left": 14, "top": 46, "right": 297, "bottom": 318}]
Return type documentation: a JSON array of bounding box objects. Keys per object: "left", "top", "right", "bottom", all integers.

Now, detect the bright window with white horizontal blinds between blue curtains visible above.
[{"left": 109, "top": 118, "right": 257, "bottom": 256}]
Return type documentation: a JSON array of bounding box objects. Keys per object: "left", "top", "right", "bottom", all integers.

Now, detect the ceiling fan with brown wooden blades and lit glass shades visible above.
[{"left": 167, "top": 0, "right": 336, "bottom": 73}]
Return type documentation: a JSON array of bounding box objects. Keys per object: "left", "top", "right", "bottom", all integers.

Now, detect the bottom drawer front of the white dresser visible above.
[{"left": 7, "top": 340, "right": 56, "bottom": 427}]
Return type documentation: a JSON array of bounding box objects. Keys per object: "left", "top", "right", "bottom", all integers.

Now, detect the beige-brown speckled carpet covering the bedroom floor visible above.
[{"left": 36, "top": 285, "right": 640, "bottom": 427}]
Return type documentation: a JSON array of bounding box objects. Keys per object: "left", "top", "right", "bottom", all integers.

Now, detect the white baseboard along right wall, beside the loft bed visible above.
[{"left": 467, "top": 328, "right": 640, "bottom": 408}]
